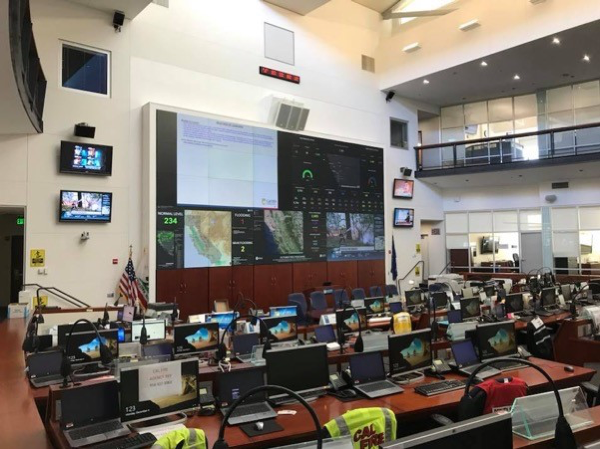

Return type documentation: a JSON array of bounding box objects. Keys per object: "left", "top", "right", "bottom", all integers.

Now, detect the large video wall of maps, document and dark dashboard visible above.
[{"left": 156, "top": 110, "right": 385, "bottom": 269}]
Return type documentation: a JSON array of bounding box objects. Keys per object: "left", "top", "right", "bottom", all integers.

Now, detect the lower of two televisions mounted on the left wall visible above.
[{"left": 58, "top": 190, "right": 112, "bottom": 223}]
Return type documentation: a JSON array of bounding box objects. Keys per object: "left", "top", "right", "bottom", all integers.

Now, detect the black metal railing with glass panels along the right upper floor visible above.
[{"left": 415, "top": 122, "right": 600, "bottom": 171}]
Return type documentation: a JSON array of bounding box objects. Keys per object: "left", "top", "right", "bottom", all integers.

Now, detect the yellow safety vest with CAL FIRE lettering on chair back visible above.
[{"left": 325, "top": 407, "right": 397, "bottom": 449}]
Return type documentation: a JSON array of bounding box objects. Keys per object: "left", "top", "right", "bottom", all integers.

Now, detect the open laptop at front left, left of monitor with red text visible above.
[{"left": 60, "top": 380, "right": 131, "bottom": 447}]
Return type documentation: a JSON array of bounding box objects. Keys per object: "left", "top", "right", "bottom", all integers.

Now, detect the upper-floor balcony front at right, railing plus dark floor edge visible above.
[{"left": 415, "top": 122, "right": 600, "bottom": 178}]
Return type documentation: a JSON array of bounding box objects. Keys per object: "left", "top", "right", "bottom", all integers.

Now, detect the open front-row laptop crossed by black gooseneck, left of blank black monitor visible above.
[{"left": 217, "top": 368, "right": 277, "bottom": 426}]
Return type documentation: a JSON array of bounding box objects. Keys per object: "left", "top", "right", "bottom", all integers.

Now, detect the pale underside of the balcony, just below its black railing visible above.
[{"left": 419, "top": 161, "right": 600, "bottom": 189}]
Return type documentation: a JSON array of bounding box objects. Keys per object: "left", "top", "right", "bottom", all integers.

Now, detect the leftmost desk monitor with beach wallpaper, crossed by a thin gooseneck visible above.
[{"left": 67, "top": 329, "right": 119, "bottom": 365}]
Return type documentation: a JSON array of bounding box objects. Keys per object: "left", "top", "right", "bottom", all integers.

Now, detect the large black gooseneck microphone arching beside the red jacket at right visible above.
[{"left": 458, "top": 357, "right": 577, "bottom": 449}]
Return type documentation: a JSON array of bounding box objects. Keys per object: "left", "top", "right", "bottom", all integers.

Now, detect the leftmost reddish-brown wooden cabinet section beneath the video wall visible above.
[{"left": 156, "top": 268, "right": 209, "bottom": 320}]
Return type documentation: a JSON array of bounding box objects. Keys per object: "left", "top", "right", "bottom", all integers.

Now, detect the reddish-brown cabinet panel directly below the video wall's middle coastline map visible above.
[{"left": 253, "top": 264, "right": 292, "bottom": 309}]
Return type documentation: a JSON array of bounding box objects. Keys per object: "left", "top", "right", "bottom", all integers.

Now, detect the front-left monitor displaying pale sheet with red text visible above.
[{"left": 121, "top": 359, "right": 198, "bottom": 423}]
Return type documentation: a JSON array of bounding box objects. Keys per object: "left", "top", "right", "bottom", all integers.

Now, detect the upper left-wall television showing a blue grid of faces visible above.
[{"left": 60, "top": 140, "right": 112, "bottom": 176}]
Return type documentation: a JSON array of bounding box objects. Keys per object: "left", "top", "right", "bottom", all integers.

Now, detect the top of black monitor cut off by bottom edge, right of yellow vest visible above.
[{"left": 381, "top": 413, "right": 513, "bottom": 449}]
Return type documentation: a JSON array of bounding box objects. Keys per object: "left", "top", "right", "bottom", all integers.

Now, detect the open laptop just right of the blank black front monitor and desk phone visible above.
[{"left": 350, "top": 351, "right": 404, "bottom": 399}]
